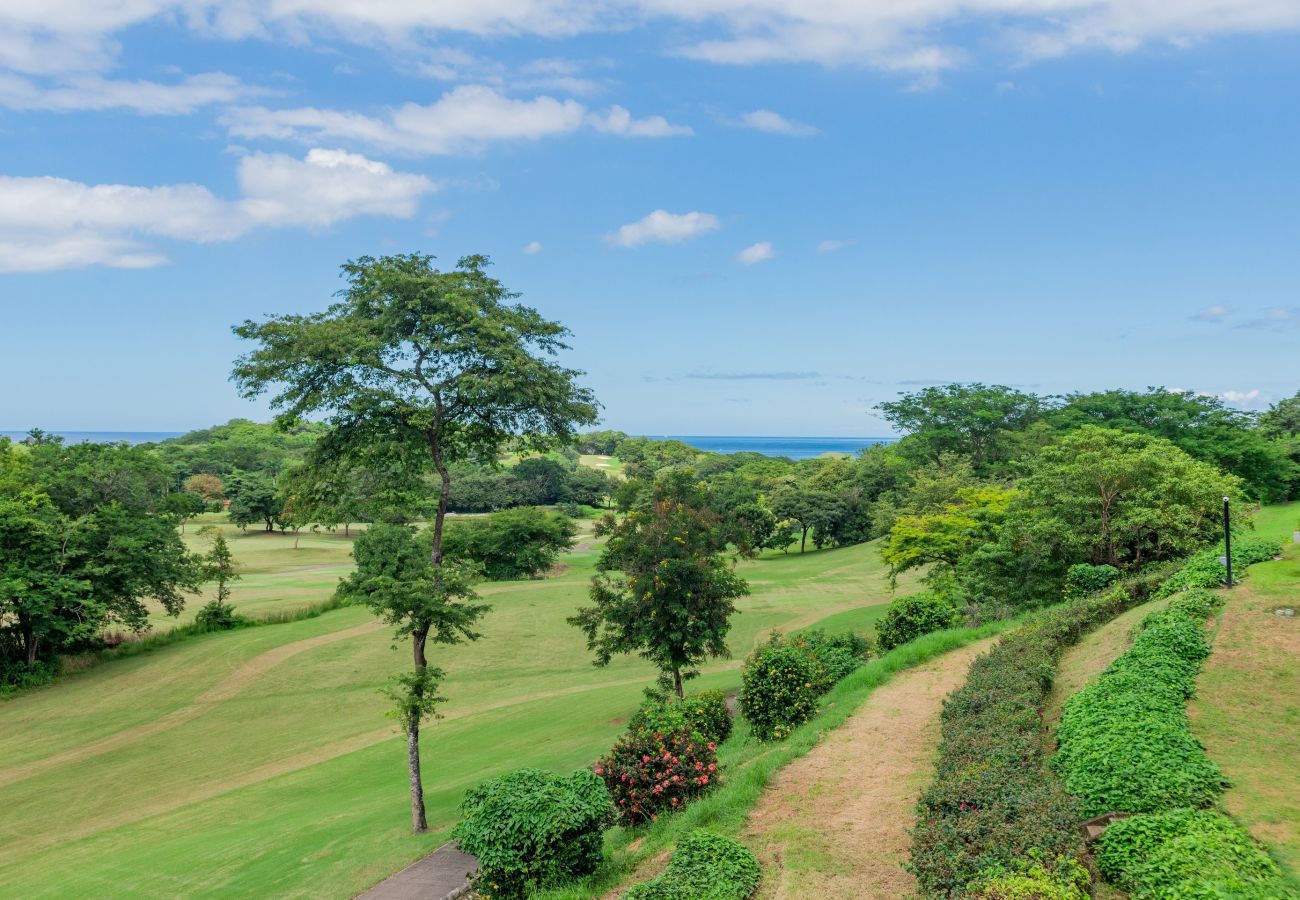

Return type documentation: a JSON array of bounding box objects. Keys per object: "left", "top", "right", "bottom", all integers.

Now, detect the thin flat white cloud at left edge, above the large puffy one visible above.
[{"left": 0, "top": 72, "right": 268, "bottom": 116}]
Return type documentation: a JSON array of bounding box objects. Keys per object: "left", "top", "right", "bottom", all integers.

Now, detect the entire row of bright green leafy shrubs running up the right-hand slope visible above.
[{"left": 1052, "top": 541, "right": 1300, "bottom": 900}]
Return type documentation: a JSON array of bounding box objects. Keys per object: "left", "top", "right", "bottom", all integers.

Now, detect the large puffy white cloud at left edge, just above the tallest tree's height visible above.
[{"left": 0, "top": 150, "right": 437, "bottom": 272}]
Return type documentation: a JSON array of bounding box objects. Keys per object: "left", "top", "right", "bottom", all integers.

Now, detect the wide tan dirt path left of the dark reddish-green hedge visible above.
[{"left": 746, "top": 639, "right": 996, "bottom": 900}]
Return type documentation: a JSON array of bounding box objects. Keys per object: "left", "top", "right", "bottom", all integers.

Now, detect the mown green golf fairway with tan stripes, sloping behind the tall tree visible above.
[{"left": 0, "top": 517, "right": 906, "bottom": 897}]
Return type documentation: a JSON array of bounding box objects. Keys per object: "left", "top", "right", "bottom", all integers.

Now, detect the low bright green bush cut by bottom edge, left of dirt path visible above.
[{"left": 623, "top": 828, "right": 759, "bottom": 900}]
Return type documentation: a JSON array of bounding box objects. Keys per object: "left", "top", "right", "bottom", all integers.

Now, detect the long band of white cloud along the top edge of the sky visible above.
[{"left": 10, "top": 0, "right": 1300, "bottom": 90}]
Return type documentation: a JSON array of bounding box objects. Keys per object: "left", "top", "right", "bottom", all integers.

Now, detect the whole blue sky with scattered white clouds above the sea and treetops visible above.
[{"left": 0, "top": 0, "right": 1300, "bottom": 436}]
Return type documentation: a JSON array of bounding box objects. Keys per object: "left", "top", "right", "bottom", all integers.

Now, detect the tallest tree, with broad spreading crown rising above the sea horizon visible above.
[{"left": 234, "top": 254, "right": 597, "bottom": 831}]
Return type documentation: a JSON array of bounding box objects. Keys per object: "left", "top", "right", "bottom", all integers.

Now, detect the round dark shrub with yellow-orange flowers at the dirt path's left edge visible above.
[{"left": 740, "top": 635, "right": 826, "bottom": 740}]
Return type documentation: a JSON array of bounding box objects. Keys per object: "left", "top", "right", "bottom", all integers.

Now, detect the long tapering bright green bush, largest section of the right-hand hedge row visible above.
[{"left": 1053, "top": 589, "right": 1225, "bottom": 815}]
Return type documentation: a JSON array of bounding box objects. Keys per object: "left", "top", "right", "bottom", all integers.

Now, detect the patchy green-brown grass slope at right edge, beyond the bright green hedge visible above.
[{"left": 1191, "top": 503, "right": 1300, "bottom": 874}]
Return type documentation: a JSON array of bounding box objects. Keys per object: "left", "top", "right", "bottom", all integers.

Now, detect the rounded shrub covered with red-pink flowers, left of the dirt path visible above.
[{"left": 594, "top": 730, "right": 720, "bottom": 825}]
